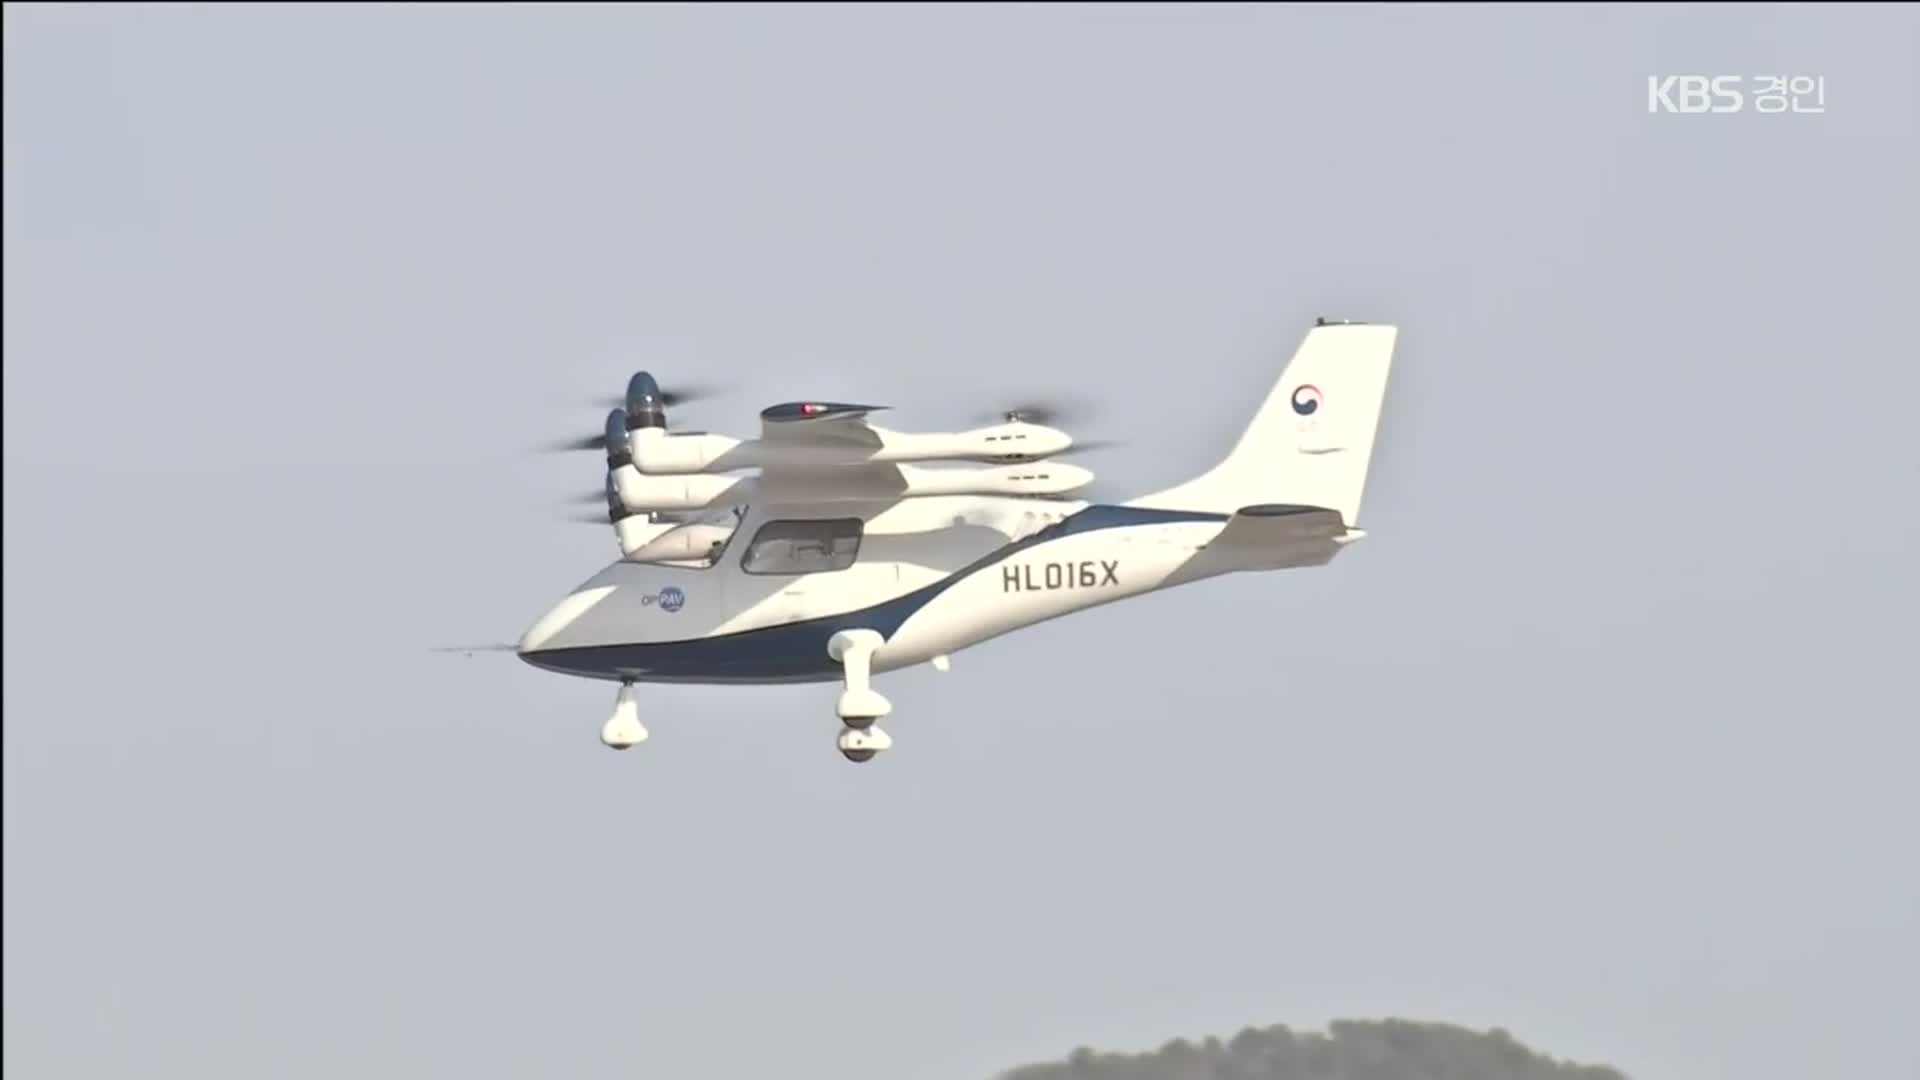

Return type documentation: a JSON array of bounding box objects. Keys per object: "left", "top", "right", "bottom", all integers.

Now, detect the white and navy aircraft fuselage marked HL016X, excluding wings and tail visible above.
[{"left": 520, "top": 496, "right": 1238, "bottom": 682}]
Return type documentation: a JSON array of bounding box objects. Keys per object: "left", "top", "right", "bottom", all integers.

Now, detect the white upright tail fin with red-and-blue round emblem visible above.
[{"left": 1127, "top": 321, "right": 1400, "bottom": 527}]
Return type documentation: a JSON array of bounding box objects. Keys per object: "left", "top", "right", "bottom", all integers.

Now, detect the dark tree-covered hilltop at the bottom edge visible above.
[{"left": 998, "top": 1020, "right": 1626, "bottom": 1080}]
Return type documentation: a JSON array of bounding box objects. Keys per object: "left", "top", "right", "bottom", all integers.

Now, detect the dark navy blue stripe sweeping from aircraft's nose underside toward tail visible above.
[{"left": 520, "top": 505, "right": 1227, "bottom": 684}]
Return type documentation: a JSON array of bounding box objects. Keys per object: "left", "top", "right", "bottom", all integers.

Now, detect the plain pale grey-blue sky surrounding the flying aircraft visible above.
[{"left": 4, "top": 6, "right": 1920, "bottom": 1080}]
